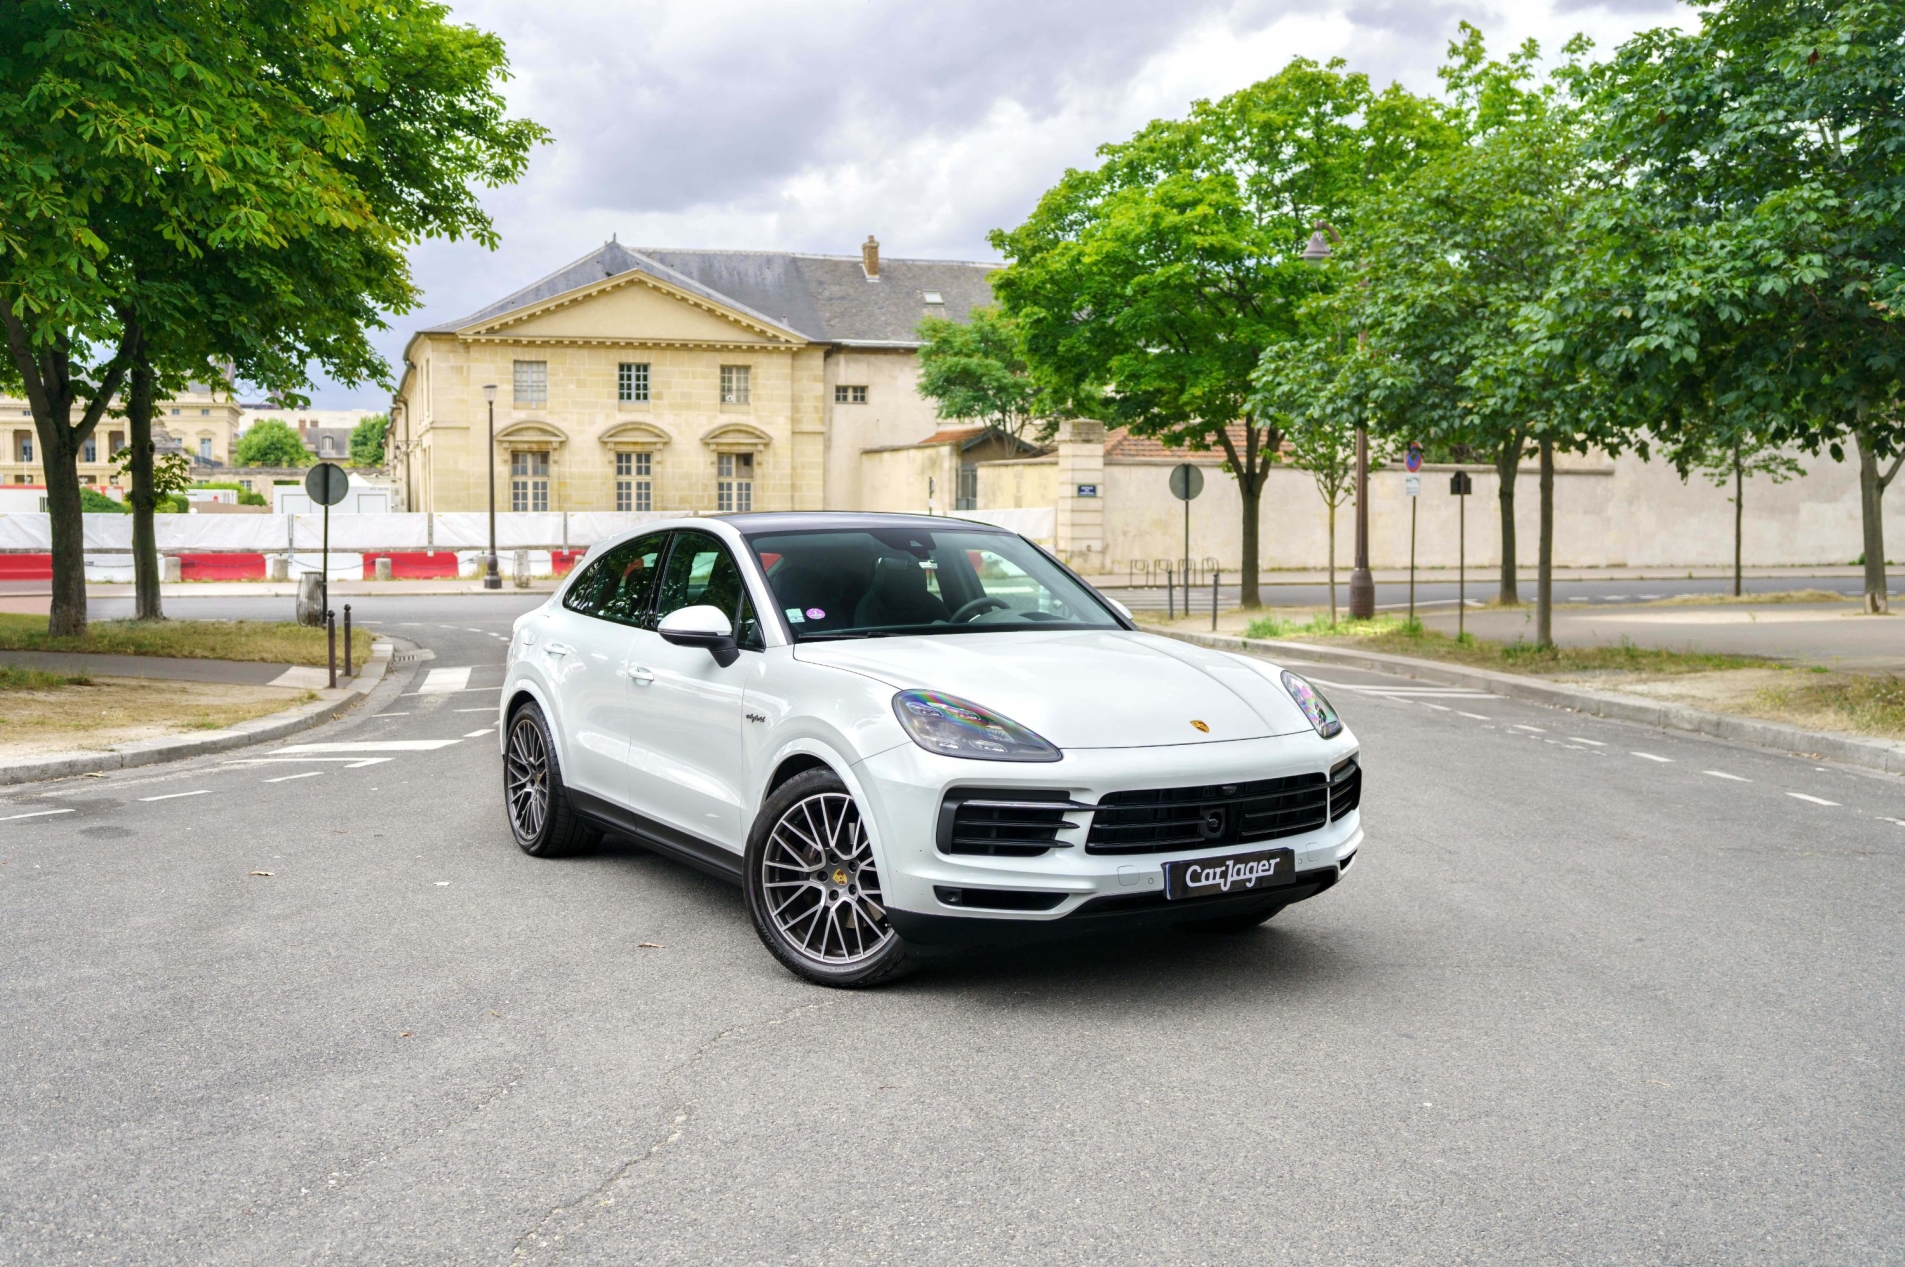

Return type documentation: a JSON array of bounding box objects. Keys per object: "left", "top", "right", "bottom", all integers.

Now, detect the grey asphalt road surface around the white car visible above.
[{"left": 0, "top": 596, "right": 1905, "bottom": 1263}]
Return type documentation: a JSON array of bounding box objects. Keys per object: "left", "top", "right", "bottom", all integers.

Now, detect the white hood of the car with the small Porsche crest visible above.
[{"left": 794, "top": 629, "right": 1311, "bottom": 749}]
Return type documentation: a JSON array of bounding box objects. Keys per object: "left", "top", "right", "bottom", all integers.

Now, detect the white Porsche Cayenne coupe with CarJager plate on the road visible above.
[{"left": 501, "top": 513, "right": 1362, "bottom": 985}]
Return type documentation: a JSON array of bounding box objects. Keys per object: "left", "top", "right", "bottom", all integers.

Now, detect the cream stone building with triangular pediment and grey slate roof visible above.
[{"left": 391, "top": 238, "right": 993, "bottom": 513}]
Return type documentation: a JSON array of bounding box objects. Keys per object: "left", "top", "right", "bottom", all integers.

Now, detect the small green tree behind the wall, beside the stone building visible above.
[{"left": 918, "top": 309, "right": 1057, "bottom": 442}]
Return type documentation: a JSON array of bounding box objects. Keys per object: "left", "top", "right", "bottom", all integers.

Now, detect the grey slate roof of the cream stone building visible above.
[{"left": 421, "top": 242, "right": 998, "bottom": 347}]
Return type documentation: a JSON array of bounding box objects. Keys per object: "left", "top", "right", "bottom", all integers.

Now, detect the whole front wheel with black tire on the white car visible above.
[{"left": 743, "top": 770, "right": 914, "bottom": 989}]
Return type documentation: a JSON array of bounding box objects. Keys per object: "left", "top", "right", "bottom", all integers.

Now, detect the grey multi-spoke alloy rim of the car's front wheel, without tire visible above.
[{"left": 760, "top": 793, "right": 893, "bottom": 966}]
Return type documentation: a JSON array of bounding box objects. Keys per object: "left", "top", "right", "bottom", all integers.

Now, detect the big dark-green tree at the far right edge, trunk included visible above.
[{"left": 1541, "top": 0, "right": 1905, "bottom": 612}]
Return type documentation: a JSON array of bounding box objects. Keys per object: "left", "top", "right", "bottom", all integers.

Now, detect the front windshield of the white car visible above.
[{"left": 749, "top": 528, "right": 1120, "bottom": 642}]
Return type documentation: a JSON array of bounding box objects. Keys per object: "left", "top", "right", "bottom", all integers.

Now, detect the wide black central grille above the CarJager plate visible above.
[{"left": 1084, "top": 774, "right": 1330, "bottom": 854}]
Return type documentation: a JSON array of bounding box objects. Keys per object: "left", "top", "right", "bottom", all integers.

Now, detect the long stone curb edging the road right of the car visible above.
[{"left": 1143, "top": 625, "right": 1905, "bottom": 775}]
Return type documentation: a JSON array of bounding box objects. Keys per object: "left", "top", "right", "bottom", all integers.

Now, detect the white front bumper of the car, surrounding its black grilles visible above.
[{"left": 853, "top": 730, "right": 1362, "bottom": 941}]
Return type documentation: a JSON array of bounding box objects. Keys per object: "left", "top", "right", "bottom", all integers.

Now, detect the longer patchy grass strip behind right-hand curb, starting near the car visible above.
[{"left": 1244, "top": 615, "right": 1779, "bottom": 676}]
